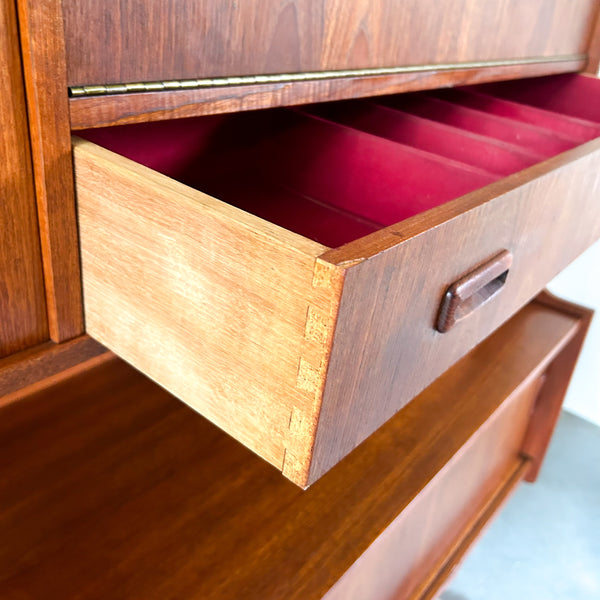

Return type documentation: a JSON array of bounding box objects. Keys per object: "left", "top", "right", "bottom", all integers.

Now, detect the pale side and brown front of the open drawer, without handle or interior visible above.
[{"left": 74, "top": 112, "right": 600, "bottom": 486}]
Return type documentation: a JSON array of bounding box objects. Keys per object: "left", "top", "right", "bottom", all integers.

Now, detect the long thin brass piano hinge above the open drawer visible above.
[{"left": 69, "top": 54, "right": 587, "bottom": 98}]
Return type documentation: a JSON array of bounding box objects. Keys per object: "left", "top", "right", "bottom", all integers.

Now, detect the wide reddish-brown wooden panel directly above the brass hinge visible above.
[{"left": 62, "top": 0, "right": 598, "bottom": 85}]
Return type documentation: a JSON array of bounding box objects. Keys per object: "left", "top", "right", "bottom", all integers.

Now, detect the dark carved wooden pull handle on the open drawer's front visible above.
[{"left": 436, "top": 250, "right": 512, "bottom": 333}]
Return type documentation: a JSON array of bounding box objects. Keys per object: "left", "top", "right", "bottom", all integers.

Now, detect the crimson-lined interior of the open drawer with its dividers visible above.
[{"left": 80, "top": 75, "right": 600, "bottom": 247}]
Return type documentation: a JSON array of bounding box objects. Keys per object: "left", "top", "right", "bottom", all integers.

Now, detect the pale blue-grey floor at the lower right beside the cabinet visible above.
[{"left": 440, "top": 413, "right": 600, "bottom": 600}]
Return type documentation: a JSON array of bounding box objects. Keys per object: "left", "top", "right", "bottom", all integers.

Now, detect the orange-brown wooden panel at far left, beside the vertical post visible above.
[{"left": 0, "top": 0, "right": 48, "bottom": 358}]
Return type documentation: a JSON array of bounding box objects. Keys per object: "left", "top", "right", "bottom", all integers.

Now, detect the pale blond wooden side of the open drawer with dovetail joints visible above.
[{"left": 74, "top": 140, "right": 341, "bottom": 483}]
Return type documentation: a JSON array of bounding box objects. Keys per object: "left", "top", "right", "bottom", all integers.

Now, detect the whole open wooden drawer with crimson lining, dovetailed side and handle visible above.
[{"left": 74, "top": 76, "right": 600, "bottom": 486}]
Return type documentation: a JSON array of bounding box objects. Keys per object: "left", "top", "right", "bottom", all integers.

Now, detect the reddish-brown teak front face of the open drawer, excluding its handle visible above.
[{"left": 310, "top": 139, "right": 600, "bottom": 481}]
